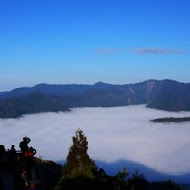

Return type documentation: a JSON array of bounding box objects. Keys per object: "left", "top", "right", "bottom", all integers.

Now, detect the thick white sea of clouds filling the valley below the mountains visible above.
[{"left": 0, "top": 105, "right": 190, "bottom": 175}]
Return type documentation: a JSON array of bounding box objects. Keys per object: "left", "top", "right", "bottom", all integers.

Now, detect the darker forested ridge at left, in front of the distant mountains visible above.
[{"left": 0, "top": 93, "right": 69, "bottom": 118}]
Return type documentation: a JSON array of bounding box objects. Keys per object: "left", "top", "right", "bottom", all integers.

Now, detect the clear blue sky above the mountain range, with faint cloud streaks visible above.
[{"left": 0, "top": 0, "right": 190, "bottom": 91}]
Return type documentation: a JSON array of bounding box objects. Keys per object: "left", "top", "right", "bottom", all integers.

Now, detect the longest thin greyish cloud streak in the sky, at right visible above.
[{"left": 128, "top": 47, "right": 185, "bottom": 55}]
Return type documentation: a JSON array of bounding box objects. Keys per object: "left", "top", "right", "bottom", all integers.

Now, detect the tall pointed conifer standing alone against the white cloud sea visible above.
[{"left": 55, "top": 129, "right": 97, "bottom": 190}]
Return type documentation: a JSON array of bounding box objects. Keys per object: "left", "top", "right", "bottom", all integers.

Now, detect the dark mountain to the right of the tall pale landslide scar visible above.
[{"left": 148, "top": 80, "right": 190, "bottom": 111}]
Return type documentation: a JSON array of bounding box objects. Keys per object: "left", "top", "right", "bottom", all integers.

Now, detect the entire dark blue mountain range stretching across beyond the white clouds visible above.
[{"left": 0, "top": 79, "right": 190, "bottom": 118}]
